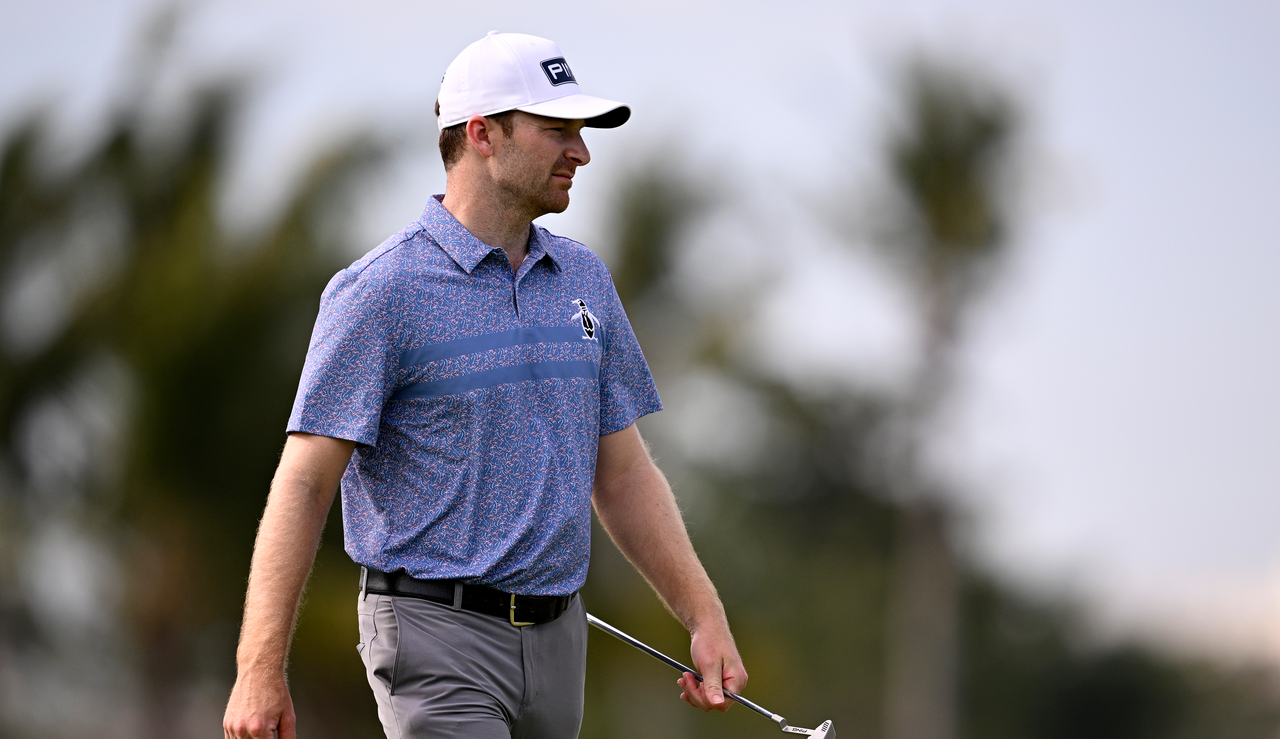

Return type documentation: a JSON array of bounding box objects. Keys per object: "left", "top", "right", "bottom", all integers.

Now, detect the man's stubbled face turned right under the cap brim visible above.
[{"left": 493, "top": 111, "right": 591, "bottom": 218}]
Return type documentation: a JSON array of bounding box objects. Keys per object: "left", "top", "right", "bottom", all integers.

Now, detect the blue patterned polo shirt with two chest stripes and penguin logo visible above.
[{"left": 288, "top": 196, "right": 662, "bottom": 596}]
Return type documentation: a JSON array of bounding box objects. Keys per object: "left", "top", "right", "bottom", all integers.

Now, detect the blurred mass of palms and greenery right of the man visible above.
[{"left": 582, "top": 58, "right": 1280, "bottom": 739}]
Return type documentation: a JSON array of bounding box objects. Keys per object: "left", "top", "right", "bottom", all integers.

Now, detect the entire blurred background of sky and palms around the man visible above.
[{"left": 0, "top": 0, "right": 1280, "bottom": 739}]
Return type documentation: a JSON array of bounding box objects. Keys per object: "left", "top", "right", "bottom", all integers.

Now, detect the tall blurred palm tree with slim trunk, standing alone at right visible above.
[{"left": 883, "top": 60, "right": 1015, "bottom": 739}]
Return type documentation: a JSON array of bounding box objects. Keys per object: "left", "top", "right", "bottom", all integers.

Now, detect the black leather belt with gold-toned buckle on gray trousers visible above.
[{"left": 360, "top": 567, "right": 576, "bottom": 626}]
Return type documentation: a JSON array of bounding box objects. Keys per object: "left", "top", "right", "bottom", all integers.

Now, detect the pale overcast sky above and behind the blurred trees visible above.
[{"left": 0, "top": 0, "right": 1280, "bottom": 661}]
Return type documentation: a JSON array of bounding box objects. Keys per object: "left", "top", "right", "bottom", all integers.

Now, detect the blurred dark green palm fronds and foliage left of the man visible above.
[{"left": 0, "top": 30, "right": 379, "bottom": 736}]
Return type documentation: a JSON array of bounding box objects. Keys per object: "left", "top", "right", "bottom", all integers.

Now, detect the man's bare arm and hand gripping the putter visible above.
[{"left": 591, "top": 424, "right": 746, "bottom": 711}]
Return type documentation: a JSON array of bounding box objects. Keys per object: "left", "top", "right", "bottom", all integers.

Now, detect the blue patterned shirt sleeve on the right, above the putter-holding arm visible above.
[{"left": 600, "top": 279, "right": 662, "bottom": 435}]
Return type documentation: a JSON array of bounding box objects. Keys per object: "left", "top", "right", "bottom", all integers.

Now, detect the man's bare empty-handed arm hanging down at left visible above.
[{"left": 223, "top": 433, "right": 356, "bottom": 739}]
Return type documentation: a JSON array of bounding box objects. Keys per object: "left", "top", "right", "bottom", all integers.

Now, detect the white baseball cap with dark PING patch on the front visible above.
[{"left": 436, "top": 31, "right": 631, "bottom": 131}]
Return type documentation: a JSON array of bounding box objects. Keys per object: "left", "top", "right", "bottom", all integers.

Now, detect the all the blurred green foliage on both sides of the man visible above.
[{"left": 0, "top": 38, "right": 1280, "bottom": 739}]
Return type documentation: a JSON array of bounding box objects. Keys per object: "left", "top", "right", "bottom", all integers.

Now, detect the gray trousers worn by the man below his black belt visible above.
[{"left": 357, "top": 593, "right": 586, "bottom": 739}]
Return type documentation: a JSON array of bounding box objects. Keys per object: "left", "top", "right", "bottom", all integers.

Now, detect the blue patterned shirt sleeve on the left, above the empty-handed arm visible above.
[{"left": 288, "top": 269, "right": 398, "bottom": 446}]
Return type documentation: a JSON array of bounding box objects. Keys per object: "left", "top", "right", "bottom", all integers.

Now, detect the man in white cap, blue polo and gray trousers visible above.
[{"left": 224, "top": 32, "right": 746, "bottom": 739}]
